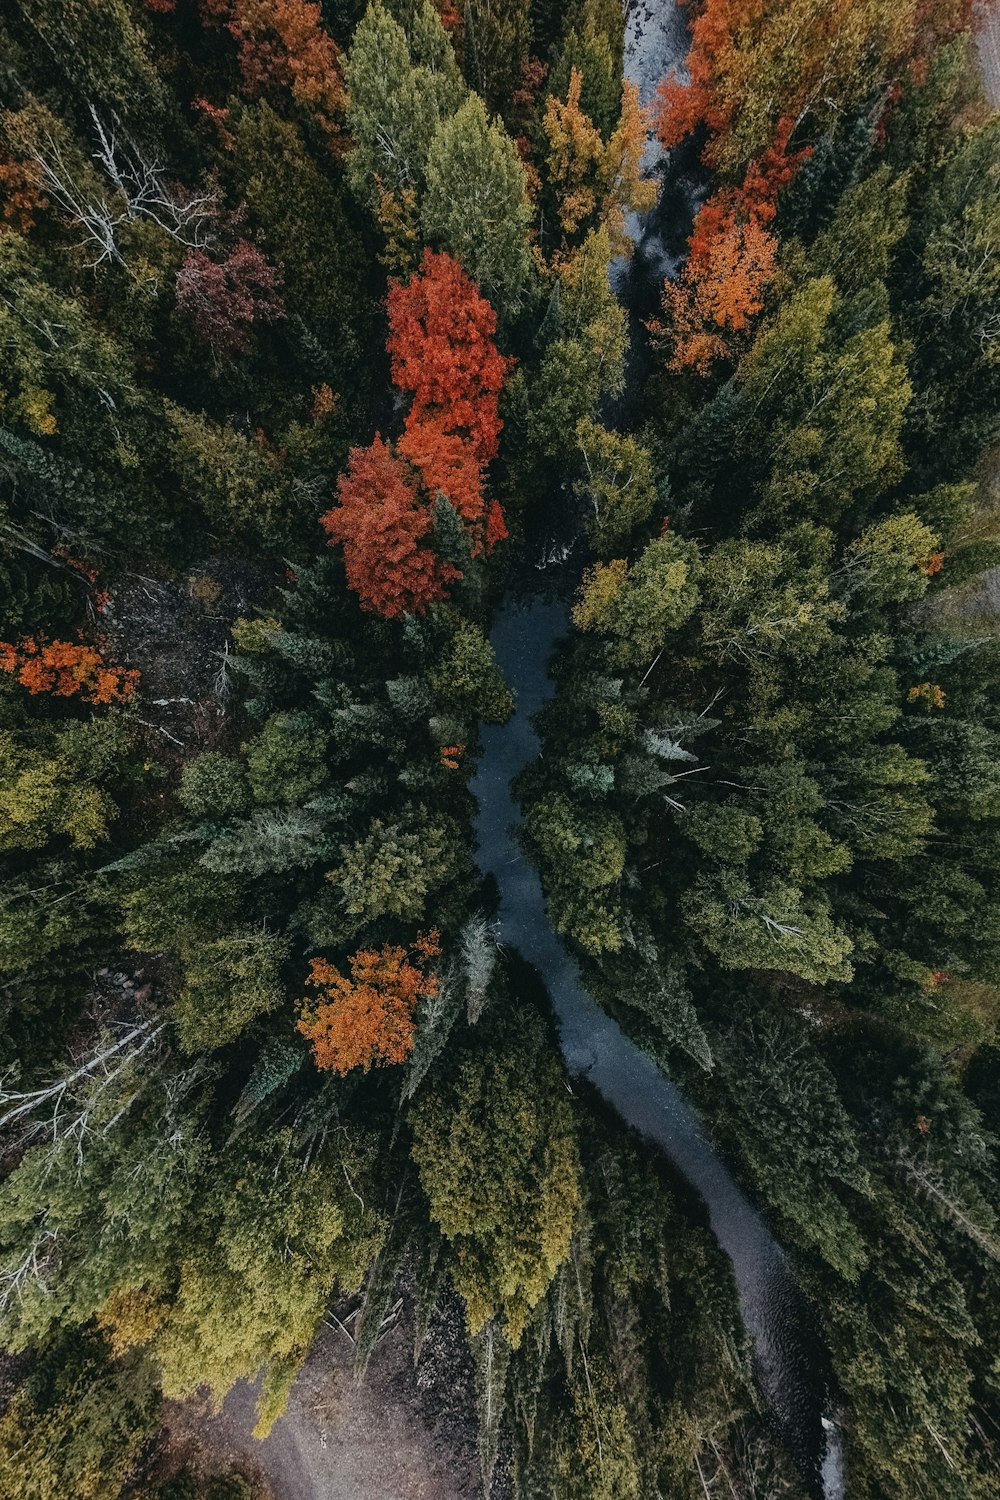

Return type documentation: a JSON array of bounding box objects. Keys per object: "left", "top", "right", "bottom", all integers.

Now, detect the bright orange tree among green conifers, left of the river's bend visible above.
[{"left": 298, "top": 932, "right": 441, "bottom": 1074}]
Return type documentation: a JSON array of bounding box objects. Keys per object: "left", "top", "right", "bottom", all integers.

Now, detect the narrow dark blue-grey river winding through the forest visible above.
[{"left": 472, "top": 0, "right": 844, "bottom": 1500}]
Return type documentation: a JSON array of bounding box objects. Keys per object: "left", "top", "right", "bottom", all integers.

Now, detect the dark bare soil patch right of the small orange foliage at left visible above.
[{"left": 103, "top": 558, "right": 274, "bottom": 761}]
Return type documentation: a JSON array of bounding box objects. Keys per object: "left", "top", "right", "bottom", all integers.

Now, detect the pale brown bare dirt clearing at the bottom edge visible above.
[{"left": 166, "top": 1307, "right": 504, "bottom": 1500}]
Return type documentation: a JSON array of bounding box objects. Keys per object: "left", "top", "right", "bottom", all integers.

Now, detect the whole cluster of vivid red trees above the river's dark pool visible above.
[{"left": 322, "top": 251, "right": 511, "bottom": 618}]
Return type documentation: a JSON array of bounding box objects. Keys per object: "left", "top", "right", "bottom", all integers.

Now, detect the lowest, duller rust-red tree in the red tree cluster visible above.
[{"left": 322, "top": 437, "right": 459, "bottom": 620}]
